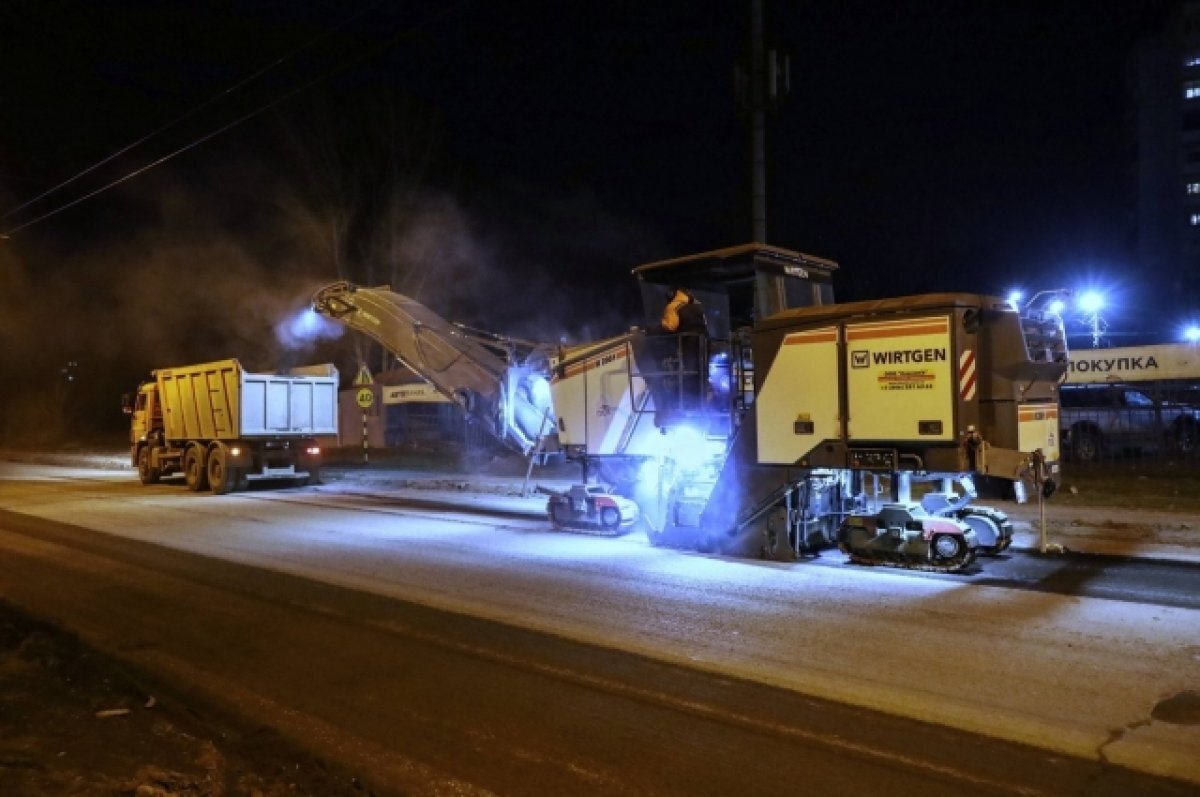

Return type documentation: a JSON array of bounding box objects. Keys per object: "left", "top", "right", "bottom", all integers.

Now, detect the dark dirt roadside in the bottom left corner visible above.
[{"left": 0, "top": 600, "right": 373, "bottom": 797}]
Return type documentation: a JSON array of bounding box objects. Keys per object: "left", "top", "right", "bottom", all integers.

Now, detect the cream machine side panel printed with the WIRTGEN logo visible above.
[{"left": 846, "top": 316, "right": 958, "bottom": 442}]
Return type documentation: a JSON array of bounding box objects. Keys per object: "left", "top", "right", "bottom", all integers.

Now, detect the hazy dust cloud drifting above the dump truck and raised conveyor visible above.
[{"left": 0, "top": 169, "right": 662, "bottom": 445}]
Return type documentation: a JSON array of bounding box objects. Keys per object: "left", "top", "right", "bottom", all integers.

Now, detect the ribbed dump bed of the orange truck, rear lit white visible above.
[{"left": 154, "top": 360, "right": 337, "bottom": 441}]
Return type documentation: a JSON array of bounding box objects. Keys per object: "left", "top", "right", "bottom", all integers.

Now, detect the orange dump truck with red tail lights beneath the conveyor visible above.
[{"left": 124, "top": 359, "right": 338, "bottom": 495}]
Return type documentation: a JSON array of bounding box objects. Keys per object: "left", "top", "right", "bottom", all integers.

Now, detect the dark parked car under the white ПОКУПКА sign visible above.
[{"left": 1060, "top": 384, "right": 1200, "bottom": 462}]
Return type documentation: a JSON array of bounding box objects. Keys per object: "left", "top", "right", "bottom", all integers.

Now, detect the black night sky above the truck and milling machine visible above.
[{"left": 0, "top": 0, "right": 1174, "bottom": 435}]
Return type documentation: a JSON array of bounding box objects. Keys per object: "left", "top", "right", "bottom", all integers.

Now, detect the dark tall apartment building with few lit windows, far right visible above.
[{"left": 1129, "top": 0, "right": 1200, "bottom": 319}]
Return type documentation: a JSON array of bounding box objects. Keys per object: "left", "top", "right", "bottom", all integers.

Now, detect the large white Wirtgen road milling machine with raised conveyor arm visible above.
[{"left": 313, "top": 244, "right": 1067, "bottom": 571}]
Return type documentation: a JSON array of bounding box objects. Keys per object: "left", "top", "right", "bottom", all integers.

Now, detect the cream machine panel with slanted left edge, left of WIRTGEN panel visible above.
[{"left": 755, "top": 326, "right": 841, "bottom": 465}]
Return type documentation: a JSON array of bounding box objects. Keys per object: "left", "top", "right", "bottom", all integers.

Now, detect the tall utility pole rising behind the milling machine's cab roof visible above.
[{"left": 734, "top": 0, "right": 791, "bottom": 244}]
